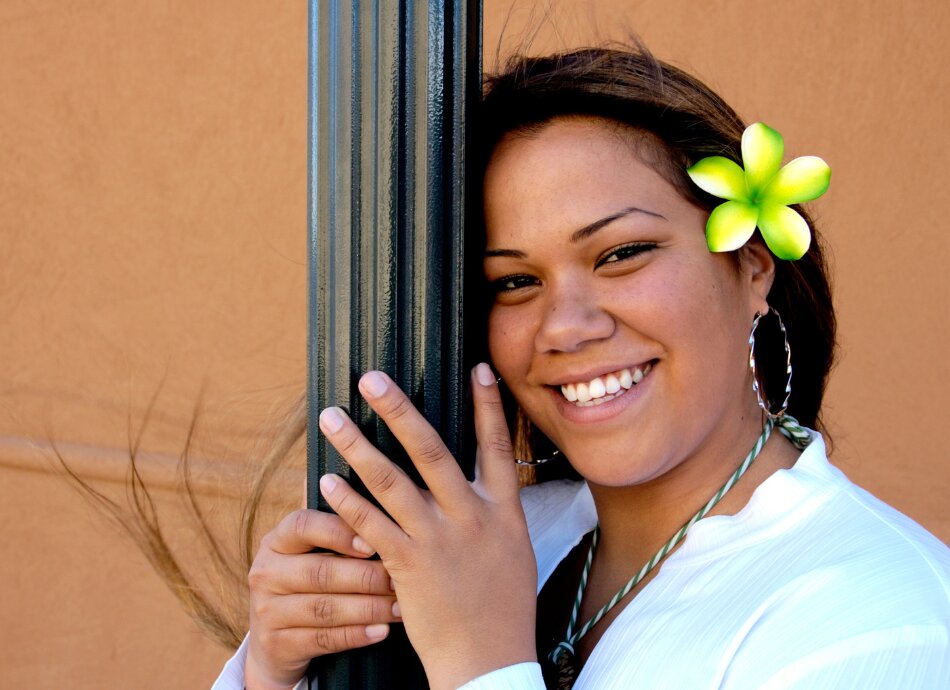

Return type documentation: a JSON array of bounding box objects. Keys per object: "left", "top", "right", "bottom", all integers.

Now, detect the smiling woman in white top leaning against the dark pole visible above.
[{"left": 215, "top": 50, "right": 950, "bottom": 690}]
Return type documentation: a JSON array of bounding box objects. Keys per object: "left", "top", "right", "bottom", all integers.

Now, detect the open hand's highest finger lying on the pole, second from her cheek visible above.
[{"left": 359, "top": 371, "right": 471, "bottom": 504}]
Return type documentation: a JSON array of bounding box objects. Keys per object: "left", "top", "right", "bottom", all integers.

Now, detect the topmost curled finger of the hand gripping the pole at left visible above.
[{"left": 262, "top": 509, "right": 373, "bottom": 558}]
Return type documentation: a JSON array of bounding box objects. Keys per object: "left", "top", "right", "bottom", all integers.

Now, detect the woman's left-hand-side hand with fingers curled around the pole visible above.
[{"left": 244, "top": 502, "right": 399, "bottom": 690}]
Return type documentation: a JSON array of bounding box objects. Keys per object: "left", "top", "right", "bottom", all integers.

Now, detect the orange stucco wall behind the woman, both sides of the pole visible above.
[{"left": 0, "top": 0, "right": 950, "bottom": 690}]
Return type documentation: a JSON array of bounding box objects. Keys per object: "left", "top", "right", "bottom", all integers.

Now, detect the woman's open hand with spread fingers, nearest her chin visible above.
[{"left": 320, "top": 364, "right": 537, "bottom": 690}]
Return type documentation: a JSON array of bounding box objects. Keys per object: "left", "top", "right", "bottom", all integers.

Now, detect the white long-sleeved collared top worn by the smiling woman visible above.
[{"left": 214, "top": 433, "right": 950, "bottom": 690}]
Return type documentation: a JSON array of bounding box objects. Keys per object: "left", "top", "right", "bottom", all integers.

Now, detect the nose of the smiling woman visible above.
[{"left": 534, "top": 286, "right": 616, "bottom": 352}]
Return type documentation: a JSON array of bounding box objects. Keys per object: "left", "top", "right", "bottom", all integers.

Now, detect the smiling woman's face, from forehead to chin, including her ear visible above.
[{"left": 485, "top": 118, "right": 774, "bottom": 486}]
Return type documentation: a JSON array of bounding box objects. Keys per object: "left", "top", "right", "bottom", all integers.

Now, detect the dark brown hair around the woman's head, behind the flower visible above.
[{"left": 478, "top": 45, "right": 836, "bottom": 464}]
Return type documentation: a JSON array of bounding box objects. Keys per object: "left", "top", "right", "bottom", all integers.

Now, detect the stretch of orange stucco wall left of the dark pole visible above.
[{"left": 0, "top": 0, "right": 307, "bottom": 690}]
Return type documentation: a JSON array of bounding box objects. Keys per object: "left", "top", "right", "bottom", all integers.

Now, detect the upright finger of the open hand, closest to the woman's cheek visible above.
[{"left": 472, "top": 363, "right": 518, "bottom": 498}]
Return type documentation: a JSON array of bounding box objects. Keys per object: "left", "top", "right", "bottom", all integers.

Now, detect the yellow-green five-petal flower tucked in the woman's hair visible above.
[{"left": 686, "top": 122, "right": 831, "bottom": 260}]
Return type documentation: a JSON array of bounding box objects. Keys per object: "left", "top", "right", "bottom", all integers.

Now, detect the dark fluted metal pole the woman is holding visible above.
[{"left": 307, "top": 0, "right": 481, "bottom": 690}]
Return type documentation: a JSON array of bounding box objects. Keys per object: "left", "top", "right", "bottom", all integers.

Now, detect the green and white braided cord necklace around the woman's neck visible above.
[{"left": 548, "top": 415, "right": 811, "bottom": 687}]
